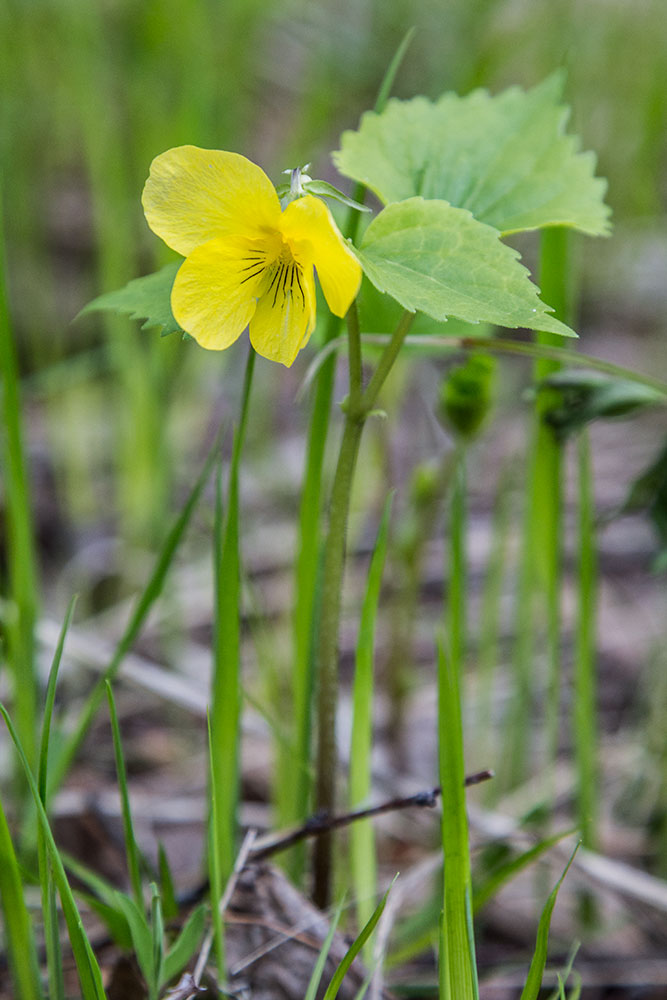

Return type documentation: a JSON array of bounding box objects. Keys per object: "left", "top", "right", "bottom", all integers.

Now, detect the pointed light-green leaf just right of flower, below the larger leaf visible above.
[{"left": 357, "top": 198, "right": 576, "bottom": 337}]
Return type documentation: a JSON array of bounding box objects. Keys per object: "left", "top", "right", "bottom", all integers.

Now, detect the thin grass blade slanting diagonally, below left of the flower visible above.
[{"left": 48, "top": 435, "right": 220, "bottom": 798}]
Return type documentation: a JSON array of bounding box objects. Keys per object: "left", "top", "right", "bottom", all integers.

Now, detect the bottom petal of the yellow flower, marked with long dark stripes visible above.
[{"left": 250, "top": 261, "right": 315, "bottom": 368}]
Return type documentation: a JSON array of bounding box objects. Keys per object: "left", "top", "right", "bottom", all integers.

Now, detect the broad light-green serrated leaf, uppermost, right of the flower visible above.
[{"left": 334, "top": 74, "right": 609, "bottom": 236}]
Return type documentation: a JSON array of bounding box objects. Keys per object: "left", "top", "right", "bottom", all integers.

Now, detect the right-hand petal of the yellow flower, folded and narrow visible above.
[{"left": 280, "top": 195, "right": 361, "bottom": 316}]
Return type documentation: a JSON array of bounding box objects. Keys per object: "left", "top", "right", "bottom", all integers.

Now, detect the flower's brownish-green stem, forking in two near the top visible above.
[{"left": 314, "top": 305, "right": 413, "bottom": 908}]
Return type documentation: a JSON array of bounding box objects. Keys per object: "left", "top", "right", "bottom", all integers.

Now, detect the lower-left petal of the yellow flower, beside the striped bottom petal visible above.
[{"left": 171, "top": 239, "right": 265, "bottom": 351}]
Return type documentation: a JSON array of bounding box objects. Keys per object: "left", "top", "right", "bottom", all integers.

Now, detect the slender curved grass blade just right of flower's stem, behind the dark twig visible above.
[{"left": 349, "top": 493, "right": 393, "bottom": 963}]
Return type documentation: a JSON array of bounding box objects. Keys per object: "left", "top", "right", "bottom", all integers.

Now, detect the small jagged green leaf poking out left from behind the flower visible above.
[{"left": 79, "top": 260, "right": 183, "bottom": 337}]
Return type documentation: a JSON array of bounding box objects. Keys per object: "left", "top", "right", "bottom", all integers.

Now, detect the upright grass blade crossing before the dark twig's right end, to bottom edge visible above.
[{"left": 438, "top": 642, "right": 479, "bottom": 1000}]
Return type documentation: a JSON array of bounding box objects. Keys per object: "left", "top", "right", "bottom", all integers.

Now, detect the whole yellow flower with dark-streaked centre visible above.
[{"left": 142, "top": 146, "right": 361, "bottom": 366}]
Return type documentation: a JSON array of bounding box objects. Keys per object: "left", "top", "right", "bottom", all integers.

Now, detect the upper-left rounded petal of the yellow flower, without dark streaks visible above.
[{"left": 142, "top": 146, "right": 280, "bottom": 256}]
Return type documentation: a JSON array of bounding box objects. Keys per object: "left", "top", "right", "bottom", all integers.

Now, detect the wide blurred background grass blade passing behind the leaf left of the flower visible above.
[{"left": 58, "top": 3, "right": 172, "bottom": 538}]
